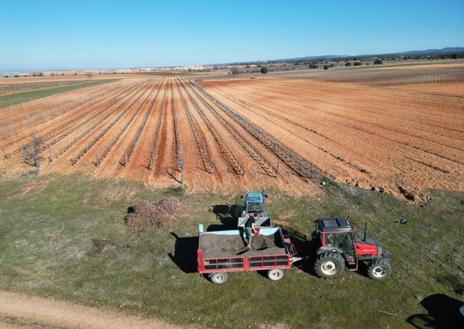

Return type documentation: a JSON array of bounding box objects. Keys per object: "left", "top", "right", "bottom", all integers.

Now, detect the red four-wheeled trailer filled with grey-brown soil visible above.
[{"left": 197, "top": 225, "right": 301, "bottom": 284}]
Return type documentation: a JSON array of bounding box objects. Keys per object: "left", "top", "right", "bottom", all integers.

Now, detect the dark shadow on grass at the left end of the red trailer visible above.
[{"left": 168, "top": 232, "right": 198, "bottom": 273}]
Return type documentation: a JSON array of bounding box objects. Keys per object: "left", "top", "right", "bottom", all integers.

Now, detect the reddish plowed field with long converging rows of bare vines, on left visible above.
[{"left": 0, "top": 78, "right": 319, "bottom": 195}]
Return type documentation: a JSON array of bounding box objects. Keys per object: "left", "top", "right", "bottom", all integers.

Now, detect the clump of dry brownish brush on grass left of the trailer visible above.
[{"left": 126, "top": 197, "right": 185, "bottom": 233}]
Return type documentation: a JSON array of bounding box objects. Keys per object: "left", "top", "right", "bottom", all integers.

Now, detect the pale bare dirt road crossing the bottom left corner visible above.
[{"left": 0, "top": 291, "right": 186, "bottom": 329}]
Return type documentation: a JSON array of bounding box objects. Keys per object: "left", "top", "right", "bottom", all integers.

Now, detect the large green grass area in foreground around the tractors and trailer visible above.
[{"left": 0, "top": 175, "right": 464, "bottom": 328}]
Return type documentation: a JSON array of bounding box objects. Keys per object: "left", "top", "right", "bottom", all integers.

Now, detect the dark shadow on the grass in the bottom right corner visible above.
[{"left": 406, "top": 294, "right": 464, "bottom": 329}]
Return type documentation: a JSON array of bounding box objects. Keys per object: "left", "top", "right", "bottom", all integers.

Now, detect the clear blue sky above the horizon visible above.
[{"left": 0, "top": 0, "right": 464, "bottom": 70}]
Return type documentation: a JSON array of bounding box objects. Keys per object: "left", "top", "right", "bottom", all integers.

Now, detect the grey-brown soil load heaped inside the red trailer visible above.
[{"left": 199, "top": 234, "right": 286, "bottom": 258}]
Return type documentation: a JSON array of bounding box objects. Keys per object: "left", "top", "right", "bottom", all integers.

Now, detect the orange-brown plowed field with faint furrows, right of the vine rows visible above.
[{"left": 204, "top": 79, "right": 464, "bottom": 200}]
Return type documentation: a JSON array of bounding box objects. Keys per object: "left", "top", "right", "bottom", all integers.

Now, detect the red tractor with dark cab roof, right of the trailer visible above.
[{"left": 314, "top": 218, "right": 392, "bottom": 280}]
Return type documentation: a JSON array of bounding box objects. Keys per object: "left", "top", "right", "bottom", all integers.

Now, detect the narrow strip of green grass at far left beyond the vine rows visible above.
[{"left": 0, "top": 79, "right": 115, "bottom": 108}]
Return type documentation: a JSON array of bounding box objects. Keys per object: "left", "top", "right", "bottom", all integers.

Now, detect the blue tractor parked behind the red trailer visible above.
[{"left": 237, "top": 192, "right": 271, "bottom": 227}]
